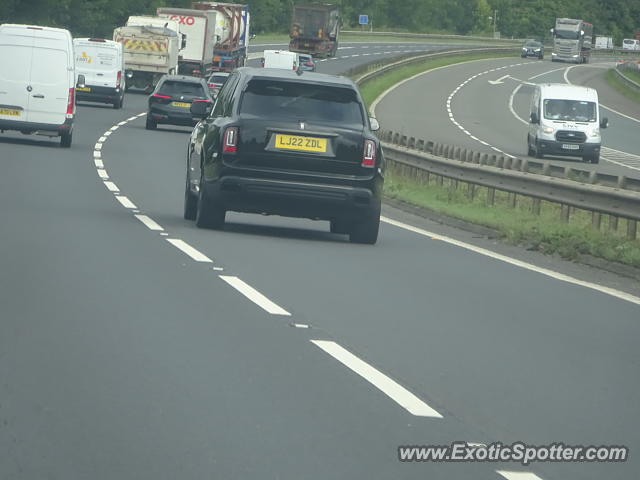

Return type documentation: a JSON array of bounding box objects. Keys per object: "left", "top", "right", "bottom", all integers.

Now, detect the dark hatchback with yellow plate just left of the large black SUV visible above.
[{"left": 146, "top": 75, "right": 213, "bottom": 130}]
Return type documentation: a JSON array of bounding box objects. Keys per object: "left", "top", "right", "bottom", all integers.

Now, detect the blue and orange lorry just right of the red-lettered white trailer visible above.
[{"left": 191, "top": 2, "right": 250, "bottom": 72}]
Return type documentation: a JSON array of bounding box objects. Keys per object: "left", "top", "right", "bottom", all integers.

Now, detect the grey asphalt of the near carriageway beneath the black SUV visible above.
[{"left": 0, "top": 45, "right": 640, "bottom": 480}]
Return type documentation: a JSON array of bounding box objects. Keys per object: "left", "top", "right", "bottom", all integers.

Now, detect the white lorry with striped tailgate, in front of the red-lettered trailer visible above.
[{"left": 113, "top": 25, "right": 181, "bottom": 91}]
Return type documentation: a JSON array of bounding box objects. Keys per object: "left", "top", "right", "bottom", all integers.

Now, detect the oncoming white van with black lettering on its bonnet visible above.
[{"left": 527, "top": 83, "right": 609, "bottom": 163}]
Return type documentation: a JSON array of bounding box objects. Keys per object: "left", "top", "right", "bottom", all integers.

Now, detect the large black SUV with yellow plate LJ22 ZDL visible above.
[{"left": 184, "top": 67, "right": 384, "bottom": 244}]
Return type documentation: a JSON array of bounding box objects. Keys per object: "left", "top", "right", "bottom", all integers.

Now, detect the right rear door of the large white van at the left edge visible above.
[{"left": 29, "top": 36, "right": 75, "bottom": 125}]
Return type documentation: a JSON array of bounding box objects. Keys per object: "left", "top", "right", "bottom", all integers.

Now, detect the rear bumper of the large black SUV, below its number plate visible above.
[{"left": 204, "top": 176, "right": 382, "bottom": 220}]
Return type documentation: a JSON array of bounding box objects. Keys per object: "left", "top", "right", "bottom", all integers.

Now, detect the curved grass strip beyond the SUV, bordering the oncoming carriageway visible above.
[{"left": 360, "top": 53, "right": 518, "bottom": 108}]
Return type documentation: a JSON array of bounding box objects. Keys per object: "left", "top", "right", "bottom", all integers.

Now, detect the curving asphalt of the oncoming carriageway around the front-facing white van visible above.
[{"left": 375, "top": 57, "right": 640, "bottom": 178}]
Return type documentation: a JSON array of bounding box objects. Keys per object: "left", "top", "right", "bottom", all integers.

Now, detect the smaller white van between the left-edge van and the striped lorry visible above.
[{"left": 73, "top": 38, "right": 125, "bottom": 108}]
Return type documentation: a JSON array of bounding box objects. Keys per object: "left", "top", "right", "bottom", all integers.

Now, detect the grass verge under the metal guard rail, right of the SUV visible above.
[{"left": 384, "top": 171, "right": 640, "bottom": 267}]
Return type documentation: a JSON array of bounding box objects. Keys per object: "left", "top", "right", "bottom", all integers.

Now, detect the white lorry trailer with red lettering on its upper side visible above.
[{"left": 157, "top": 7, "right": 218, "bottom": 76}]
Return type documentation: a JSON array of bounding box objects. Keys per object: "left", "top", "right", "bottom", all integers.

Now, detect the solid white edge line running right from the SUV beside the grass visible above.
[{"left": 380, "top": 217, "right": 640, "bottom": 305}]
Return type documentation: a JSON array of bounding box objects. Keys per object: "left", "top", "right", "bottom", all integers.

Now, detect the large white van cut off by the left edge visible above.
[{"left": 0, "top": 24, "right": 76, "bottom": 147}]
